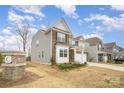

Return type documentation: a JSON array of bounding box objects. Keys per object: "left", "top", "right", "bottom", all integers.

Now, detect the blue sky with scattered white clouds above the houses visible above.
[{"left": 0, "top": 5, "right": 124, "bottom": 50}]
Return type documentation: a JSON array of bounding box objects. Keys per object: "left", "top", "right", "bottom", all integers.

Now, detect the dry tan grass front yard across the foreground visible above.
[{"left": 0, "top": 63, "right": 124, "bottom": 88}]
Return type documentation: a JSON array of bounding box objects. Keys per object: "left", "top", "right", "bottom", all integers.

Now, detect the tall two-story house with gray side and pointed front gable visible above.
[{"left": 31, "top": 18, "right": 72, "bottom": 63}]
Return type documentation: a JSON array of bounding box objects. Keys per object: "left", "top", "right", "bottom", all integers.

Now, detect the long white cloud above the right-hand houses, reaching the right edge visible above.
[{"left": 84, "top": 14, "right": 124, "bottom": 31}]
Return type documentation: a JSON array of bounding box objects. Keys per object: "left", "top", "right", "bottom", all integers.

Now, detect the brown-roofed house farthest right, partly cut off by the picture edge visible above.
[{"left": 104, "top": 42, "right": 123, "bottom": 59}]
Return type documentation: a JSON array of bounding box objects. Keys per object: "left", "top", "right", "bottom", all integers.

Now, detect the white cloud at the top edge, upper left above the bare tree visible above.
[{"left": 15, "top": 5, "right": 45, "bottom": 17}]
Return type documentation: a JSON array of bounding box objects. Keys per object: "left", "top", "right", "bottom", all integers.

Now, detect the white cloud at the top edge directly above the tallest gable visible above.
[{"left": 55, "top": 5, "right": 79, "bottom": 19}]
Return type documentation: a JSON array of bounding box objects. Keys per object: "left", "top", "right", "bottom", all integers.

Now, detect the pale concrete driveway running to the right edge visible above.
[{"left": 87, "top": 62, "right": 124, "bottom": 71}]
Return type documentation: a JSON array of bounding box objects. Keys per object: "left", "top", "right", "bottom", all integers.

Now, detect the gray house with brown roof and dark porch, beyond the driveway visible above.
[{"left": 85, "top": 37, "right": 112, "bottom": 62}]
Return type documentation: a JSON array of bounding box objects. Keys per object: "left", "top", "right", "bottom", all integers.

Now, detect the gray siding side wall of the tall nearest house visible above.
[{"left": 31, "top": 31, "right": 52, "bottom": 63}]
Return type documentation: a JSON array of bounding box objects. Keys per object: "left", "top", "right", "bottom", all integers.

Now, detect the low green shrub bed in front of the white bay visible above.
[{"left": 58, "top": 63, "right": 86, "bottom": 70}]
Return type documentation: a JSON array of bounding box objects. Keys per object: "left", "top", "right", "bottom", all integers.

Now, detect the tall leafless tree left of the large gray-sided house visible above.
[{"left": 16, "top": 23, "right": 30, "bottom": 51}]
